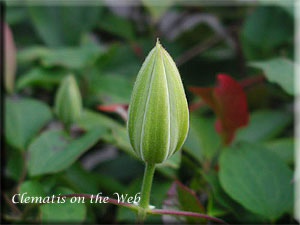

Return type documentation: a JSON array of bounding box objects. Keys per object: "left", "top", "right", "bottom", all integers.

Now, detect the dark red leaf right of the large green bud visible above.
[{"left": 190, "top": 74, "right": 249, "bottom": 145}]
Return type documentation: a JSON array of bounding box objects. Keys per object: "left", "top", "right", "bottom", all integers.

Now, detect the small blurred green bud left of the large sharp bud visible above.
[{"left": 54, "top": 75, "right": 82, "bottom": 125}]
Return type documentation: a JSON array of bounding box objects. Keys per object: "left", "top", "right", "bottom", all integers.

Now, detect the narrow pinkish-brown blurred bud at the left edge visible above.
[{"left": 4, "top": 24, "right": 16, "bottom": 93}]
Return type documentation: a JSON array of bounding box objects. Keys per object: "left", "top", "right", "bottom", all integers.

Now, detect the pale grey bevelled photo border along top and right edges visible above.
[{"left": 0, "top": 0, "right": 300, "bottom": 223}]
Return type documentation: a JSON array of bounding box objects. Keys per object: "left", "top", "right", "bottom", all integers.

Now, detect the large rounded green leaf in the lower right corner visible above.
[{"left": 219, "top": 142, "right": 293, "bottom": 221}]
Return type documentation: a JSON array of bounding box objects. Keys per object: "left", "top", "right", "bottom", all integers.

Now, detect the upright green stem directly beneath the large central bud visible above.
[{"left": 138, "top": 163, "right": 155, "bottom": 222}]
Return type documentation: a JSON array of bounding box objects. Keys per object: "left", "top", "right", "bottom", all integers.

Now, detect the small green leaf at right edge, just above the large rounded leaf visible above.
[{"left": 264, "top": 137, "right": 295, "bottom": 164}]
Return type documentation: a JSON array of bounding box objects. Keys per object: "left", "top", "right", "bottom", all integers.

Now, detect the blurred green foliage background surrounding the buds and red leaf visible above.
[{"left": 2, "top": 0, "right": 295, "bottom": 224}]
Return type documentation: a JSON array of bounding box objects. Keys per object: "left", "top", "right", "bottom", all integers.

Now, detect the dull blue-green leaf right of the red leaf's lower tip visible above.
[{"left": 235, "top": 110, "right": 292, "bottom": 142}]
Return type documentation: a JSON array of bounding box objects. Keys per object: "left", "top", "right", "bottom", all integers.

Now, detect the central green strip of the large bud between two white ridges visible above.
[{"left": 141, "top": 42, "right": 170, "bottom": 162}]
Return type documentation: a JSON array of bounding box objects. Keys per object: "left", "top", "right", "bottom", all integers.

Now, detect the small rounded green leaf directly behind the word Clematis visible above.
[{"left": 19, "top": 180, "right": 46, "bottom": 200}]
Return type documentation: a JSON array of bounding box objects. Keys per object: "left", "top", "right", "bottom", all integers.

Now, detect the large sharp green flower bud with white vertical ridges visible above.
[{"left": 127, "top": 40, "right": 189, "bottom": 164}]
